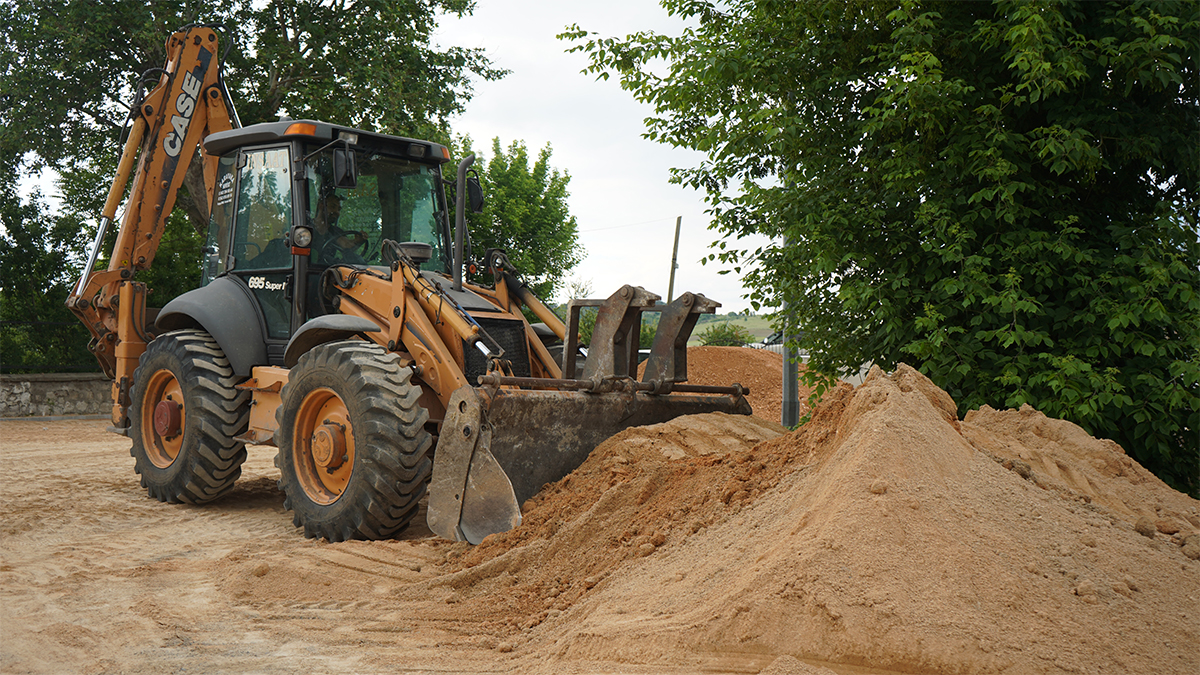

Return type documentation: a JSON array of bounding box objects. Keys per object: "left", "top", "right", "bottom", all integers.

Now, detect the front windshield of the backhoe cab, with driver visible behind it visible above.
[{"left": 306, "top": 150, "right": 450, "bottom": 271}]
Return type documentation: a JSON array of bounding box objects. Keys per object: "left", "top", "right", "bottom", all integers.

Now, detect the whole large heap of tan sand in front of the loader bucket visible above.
[{"left": 437, "top": 366, "right": 1200, "bottom": 673}]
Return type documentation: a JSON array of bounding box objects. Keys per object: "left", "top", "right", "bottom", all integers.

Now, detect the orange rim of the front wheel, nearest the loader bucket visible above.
[{"left": 292, "top": 388, "right": 354, "bottom": 504}]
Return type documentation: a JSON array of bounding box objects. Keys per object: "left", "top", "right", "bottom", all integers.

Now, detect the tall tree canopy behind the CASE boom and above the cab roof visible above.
[{"left": 0, "top": 0, "right": 504, "bottom": 233}]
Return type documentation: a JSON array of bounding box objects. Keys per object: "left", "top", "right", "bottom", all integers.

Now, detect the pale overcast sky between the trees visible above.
[{"left": 437, "top": 0, "right": 764, "bottom": 313}]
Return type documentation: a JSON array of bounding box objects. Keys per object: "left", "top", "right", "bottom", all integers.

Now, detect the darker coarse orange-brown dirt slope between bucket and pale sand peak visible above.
[{"left": 434, "top": 413, "right": 792, "bottom": 637}]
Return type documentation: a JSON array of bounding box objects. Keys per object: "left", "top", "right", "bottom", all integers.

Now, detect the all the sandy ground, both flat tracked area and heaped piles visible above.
[{"left": 0, "top": 355, "right": 1200, "bottom": 675}]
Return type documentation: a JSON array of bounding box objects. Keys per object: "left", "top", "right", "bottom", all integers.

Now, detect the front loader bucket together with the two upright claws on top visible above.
[{"left": 428, "top": 286, "right": 750, "bottom": 544}]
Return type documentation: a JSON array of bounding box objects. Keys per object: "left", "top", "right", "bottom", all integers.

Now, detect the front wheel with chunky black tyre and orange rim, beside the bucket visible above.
[{"left": 275, "top": 340, "right": 433, "bottom": 542}]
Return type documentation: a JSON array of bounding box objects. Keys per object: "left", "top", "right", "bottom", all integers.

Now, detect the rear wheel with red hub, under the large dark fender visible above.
[{"left": 130, "top": 329, "right": 250, "bottom": 504}]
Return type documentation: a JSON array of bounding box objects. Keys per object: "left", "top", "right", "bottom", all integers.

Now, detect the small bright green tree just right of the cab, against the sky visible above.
[{"left": 460, "top": 138, "right": 583, "bottom": 301}]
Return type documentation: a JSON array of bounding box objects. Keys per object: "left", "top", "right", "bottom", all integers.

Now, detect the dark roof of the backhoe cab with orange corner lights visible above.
[{"left": 204, "top": 119, "right": 450, "bottom": 165}]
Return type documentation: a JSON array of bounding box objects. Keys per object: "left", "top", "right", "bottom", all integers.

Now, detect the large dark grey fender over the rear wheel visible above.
[{"left": 155, "top": 276, "right": 266, "bottom": 377}]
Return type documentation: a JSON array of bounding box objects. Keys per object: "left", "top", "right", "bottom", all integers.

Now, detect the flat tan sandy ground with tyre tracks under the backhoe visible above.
[{"left": 0, "top": 420, "right": 868, "bottom": 674}]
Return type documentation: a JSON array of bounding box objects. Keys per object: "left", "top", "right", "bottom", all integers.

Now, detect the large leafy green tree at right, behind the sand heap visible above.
[{"left": 564, "top": 0, "right": 1200, "bottom": 495}]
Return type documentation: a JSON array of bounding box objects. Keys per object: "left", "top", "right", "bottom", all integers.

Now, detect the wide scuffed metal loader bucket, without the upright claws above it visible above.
[{"left": 428, "top": 381, "right": 750, "bottom": 544}]
